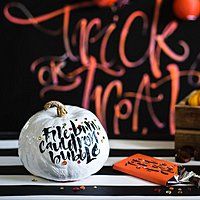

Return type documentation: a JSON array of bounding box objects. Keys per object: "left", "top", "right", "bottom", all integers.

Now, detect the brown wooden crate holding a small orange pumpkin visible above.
[{"left": 175, "top": 91, "right": 200, "bottom": 149}]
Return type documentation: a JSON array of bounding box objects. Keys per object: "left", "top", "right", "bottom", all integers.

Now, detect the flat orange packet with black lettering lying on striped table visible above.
[{"left": 113, "top": 154, "right": 178, "bottom": 185}]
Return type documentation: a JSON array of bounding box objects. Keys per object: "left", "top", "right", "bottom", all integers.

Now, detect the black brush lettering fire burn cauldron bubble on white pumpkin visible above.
[{"left": 39, "top": 121, "right": 100, "bottom": 164}]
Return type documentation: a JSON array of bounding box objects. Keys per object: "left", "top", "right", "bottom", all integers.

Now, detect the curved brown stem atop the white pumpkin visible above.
[{"left": 44, "top": 101, "right": 67, "bottom": 117}]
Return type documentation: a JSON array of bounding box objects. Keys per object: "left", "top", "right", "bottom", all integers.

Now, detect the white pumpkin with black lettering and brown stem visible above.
[{"left": 18, "top": 101, "right": 109, "bottom": 181}]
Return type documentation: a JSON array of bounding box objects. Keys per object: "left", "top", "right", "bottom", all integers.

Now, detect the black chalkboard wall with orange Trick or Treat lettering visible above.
[{"left": 0, "top": 0, "right": 200, "bottom": 140}]
